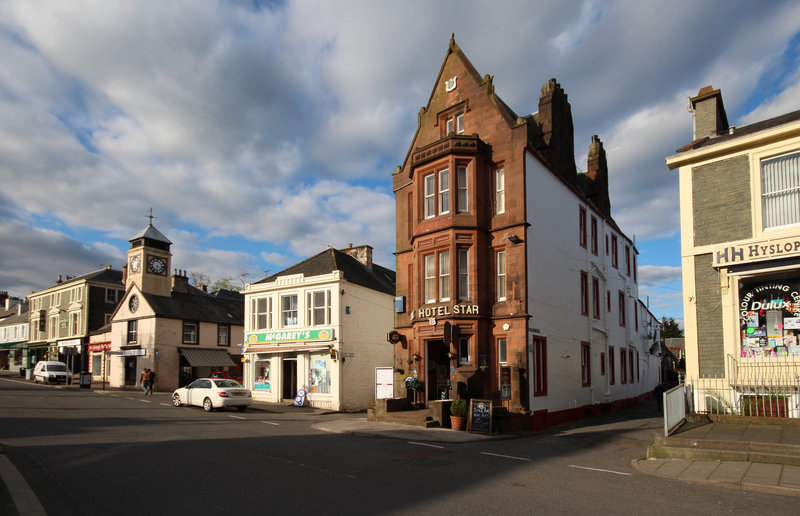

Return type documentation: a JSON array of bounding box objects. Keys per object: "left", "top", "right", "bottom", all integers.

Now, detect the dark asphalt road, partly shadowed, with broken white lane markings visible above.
[{"left": 0, "top": 378, "right": 797, "bottom": 516}]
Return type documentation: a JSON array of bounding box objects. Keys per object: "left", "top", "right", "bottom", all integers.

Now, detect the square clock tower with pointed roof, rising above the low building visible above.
[{"left": 125, "top": 219, "right": 172, "bottom": 296}]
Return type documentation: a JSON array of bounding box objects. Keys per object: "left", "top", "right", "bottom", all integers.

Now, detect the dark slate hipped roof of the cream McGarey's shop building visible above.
[{"left": 255, "top": 249, "right": 396, "bottom": 295}]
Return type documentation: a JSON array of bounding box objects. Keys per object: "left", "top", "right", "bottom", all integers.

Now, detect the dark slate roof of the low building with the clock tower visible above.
[{"left": 142, "top": 286, "right": 244, "bottom": 326}]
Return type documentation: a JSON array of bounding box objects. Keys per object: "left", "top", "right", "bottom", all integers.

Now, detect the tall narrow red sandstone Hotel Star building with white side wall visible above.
[{"left": 390, "top": 39, "right": 659, "bottom": 427}]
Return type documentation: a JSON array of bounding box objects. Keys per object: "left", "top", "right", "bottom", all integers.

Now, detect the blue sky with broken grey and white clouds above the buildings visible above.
[{"left": 0, "top": 0, "right": 800, "bottom": 321}]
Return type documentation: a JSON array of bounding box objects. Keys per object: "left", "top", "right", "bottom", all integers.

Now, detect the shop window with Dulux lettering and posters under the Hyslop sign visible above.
[{"left": 739, "top": 278, "right": 800, "bottom": 358}]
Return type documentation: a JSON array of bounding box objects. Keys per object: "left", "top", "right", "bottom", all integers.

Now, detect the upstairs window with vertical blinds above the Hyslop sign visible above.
[{"left": 759, "top": 151, "right": 800, "bottom": 231}]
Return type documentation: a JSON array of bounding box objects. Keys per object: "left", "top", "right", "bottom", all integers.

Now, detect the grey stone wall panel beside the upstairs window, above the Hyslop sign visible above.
[{"left": 692, "top": 156, "right": 753, "bottom": 246}]
